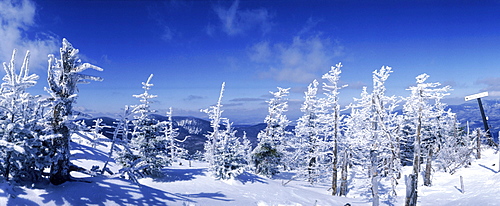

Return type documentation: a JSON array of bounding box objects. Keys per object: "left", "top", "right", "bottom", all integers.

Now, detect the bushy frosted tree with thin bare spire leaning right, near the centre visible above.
[{"left": 201, "top": 83, "right": 248, "bottom": 179}]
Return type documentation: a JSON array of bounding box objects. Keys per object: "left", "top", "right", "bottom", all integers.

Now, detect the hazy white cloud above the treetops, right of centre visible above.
[{"left": 254, "top": 36, "right": 343, "bottom": 83}]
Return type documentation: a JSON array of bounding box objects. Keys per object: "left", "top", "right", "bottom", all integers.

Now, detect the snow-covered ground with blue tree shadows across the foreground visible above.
[{"left": 0, "top": 133, "right": 500, "bottom": 206}]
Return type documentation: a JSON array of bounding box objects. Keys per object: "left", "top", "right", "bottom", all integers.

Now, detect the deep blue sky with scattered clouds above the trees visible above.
[{"left": 0, "top": 0, "right": 500, "bottom": 123}]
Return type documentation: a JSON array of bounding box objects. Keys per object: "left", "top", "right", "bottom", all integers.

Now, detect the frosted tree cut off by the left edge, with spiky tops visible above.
[{"left": 0, "top": 50, "right": 50, "bottom": 182}]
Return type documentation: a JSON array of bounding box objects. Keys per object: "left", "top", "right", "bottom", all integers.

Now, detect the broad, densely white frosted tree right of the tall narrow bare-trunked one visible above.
[{"left": 341, "top": 67, "right": 400, "bottom": 205}]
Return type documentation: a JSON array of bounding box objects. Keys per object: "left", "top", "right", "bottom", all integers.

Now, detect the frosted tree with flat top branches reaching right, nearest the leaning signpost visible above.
[{"left": 403, "top": 74, "right": 450, "bottom": 206}]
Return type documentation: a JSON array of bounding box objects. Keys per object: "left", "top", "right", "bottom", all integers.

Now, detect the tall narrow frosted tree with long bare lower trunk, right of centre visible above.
[{"left": 322, "top": 63, "right": 347, "bottom": 195}]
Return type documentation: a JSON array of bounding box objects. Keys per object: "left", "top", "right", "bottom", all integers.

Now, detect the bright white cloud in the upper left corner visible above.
[{"left": 0, "top": 0, "right": 58, "bottom": 71}]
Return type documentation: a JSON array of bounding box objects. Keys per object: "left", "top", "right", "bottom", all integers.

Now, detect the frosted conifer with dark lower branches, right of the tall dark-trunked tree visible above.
[{"left": 119, "top": 74, "right": 167, "bottom": 182}]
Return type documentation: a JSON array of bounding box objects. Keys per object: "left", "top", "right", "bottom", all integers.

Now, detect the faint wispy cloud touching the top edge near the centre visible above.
[{"left": 212, "top": 0, "right": 272, "bottom": 36}]
